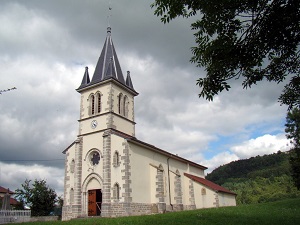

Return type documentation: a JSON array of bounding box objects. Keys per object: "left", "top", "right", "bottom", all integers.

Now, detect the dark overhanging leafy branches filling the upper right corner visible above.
[{"left": 151, "top": 0, "right": 300, "bottom": 109}]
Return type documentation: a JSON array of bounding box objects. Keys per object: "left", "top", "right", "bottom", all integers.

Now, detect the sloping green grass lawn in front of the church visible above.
[{"left": 12, "top": 198, "right": 300, "bottom": 225}]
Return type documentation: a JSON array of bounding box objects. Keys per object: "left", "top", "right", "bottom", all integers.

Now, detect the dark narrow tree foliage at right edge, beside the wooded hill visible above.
[{"left": 285, "top": 108, "right": 300, "bottom": 190}]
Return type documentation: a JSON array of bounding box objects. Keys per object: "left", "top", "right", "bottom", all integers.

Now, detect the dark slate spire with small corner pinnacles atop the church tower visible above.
[{"left": 77, "top": 27, "right": 135, "bottom": 92}]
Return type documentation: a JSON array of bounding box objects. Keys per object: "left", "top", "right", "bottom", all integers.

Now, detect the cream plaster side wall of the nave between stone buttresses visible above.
[{"left": 130, "top": 144, "right": 204, "bottom": 205}]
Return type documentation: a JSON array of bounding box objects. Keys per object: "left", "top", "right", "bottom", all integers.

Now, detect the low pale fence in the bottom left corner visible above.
[{"left": 0, "top": 210, "right": 31, "bottom": 224}]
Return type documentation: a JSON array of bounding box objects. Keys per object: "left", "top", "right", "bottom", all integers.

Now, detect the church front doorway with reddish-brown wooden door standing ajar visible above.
[{"left": 88, "top": 189, "right": 102, "bottom": 216}]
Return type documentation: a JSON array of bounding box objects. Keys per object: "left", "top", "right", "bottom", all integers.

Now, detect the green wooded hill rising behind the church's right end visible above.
[{"left": 206, "top": 151, "right": 300, "bottom": 204}]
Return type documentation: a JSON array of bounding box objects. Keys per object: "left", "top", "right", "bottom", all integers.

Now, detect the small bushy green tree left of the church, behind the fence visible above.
[{"left": 16, "top": 179, "right": 57, "bottom": 216}]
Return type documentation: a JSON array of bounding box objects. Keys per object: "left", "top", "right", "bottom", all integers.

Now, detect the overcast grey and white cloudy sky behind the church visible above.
[{"left": 0, "top": 0, "right": 289, "bottom": 197}]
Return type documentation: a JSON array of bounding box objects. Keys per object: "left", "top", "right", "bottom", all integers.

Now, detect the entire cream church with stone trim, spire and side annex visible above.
[{"left": 62, "top": 27, "right": 236, "bottom": 220}]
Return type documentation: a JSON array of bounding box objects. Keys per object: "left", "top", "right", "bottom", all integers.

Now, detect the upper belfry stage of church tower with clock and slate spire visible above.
[{"left": 76, "top": 27, "right": 138, "bottom": 136}]
